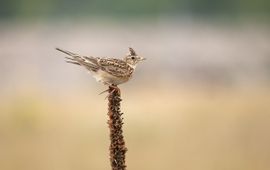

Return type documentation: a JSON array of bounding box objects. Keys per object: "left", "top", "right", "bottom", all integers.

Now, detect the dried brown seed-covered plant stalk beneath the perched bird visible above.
[{"left": 108, "top": 87, "right": 127, "bottom": 170}]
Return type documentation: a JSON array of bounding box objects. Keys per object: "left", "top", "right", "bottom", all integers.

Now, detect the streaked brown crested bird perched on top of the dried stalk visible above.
[{"left": 55, "top": 47, "right": 146, "bottom": 92}]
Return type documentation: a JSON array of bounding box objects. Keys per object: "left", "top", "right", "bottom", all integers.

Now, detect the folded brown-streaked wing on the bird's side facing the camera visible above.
[{"left": 98, "top": 58, "right": 133, "bottom": 77}]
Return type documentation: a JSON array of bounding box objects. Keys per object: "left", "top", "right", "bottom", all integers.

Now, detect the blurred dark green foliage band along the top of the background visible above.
[{"left": 0, "top": 0, "right": 270, "bottom": 19}]
